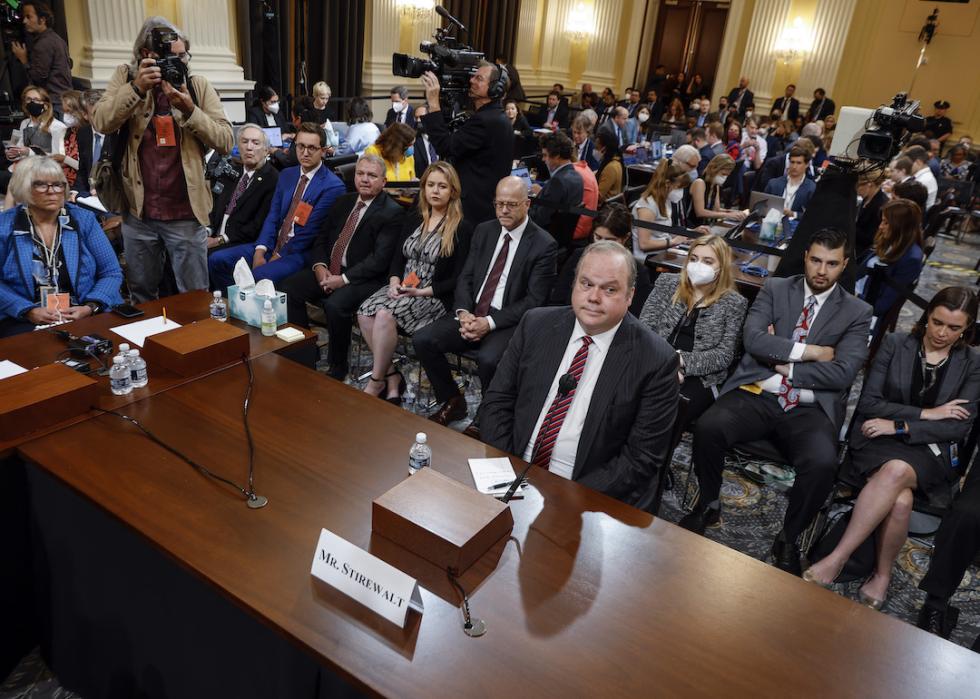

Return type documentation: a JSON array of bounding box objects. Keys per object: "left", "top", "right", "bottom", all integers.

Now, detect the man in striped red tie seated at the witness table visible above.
[{"left": 480, "top": 241, "right": 678, "bottom": 509}]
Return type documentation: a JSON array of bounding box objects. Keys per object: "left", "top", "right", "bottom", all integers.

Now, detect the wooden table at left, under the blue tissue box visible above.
[{"left": 0, "top": 291, "right": 316, "bottom": 455}]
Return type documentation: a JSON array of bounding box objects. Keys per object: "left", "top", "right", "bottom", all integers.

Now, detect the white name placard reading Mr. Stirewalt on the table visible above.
[{"left": 310, "top": 529, "right": 423, "bottom": 628}]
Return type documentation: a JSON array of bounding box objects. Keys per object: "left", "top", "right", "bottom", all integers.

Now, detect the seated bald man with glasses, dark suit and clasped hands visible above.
[{"left": 412, "top": 176, "right": 558, "bottom": 425}]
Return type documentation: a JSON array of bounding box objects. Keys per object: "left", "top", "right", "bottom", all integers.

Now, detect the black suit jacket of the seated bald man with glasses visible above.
[{"left": 453, "top": 219, "right": 558, "bottom": 330}]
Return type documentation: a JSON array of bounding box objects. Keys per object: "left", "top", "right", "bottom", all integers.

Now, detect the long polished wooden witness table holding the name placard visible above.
[{"left": 13, "top": 354, "right": 980, "bottom": 697}]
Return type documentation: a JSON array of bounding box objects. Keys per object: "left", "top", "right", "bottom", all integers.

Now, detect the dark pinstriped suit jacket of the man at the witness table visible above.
[{"left": 480, "top": 306, "right": 679, "bottom": 509}]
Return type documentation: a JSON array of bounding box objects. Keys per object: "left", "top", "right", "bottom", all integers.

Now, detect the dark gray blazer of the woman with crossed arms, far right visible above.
[{"left": 848, "top": 332, "right": 980, "bottom": 467}]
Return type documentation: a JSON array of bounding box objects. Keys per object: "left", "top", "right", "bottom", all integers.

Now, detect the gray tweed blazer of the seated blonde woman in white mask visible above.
[{"left": 640, "top": 273, "right": 749, "bottom": 386}]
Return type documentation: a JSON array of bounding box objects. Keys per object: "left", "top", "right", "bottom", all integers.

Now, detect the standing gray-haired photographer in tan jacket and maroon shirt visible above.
[{"left": 92, "top": 17, "right": 234, "bottom": 303}]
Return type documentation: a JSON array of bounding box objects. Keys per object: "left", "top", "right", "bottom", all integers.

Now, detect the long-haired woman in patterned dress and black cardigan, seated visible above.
[{"left": 357, "top": 160, "right": 473, "bottom": 405}]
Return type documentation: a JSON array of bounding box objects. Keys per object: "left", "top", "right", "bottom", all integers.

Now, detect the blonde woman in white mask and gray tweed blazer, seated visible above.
[{"left": 640, "top": 235, "right": 748, "bottom": 429}]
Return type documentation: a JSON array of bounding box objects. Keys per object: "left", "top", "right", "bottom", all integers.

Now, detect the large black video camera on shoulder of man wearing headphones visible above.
[{"left": 391, "top": 5, "right": 485, "bottom": 122}]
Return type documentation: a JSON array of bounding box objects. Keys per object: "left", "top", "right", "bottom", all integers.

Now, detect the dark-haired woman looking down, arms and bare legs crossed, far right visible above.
[{"left": 803, "top": 287, "right": 980, "bottom": 609}]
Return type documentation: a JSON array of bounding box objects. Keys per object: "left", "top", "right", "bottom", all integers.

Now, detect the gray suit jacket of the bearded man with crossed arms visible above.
[{"left": 721, "top": 274, "right": 871, "bottom": 425}]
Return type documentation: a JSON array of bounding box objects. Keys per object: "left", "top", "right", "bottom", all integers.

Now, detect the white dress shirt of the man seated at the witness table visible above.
[{"left": 523, "top": 320, "right": 623, "bottom": 480}]
